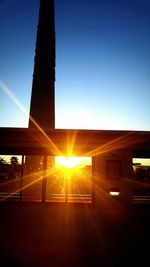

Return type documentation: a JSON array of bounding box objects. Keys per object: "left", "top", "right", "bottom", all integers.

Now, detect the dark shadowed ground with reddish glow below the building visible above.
[{"left": 0, "top": 200, "right": 150, "bottom": 267}]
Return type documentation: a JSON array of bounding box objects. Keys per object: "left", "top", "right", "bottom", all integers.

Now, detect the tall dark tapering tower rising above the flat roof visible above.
[{"left": 29, "top": 0, "right": 55, "bottom": 130}]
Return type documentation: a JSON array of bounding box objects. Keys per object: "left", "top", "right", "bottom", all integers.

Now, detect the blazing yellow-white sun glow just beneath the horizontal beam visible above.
[{"left": 56, "top": 156, "right": 89, "bottom": 169}]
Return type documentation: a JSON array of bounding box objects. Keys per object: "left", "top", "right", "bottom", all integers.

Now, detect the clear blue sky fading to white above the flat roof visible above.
[{"left": 0, "top": 0, "right": 150, "bottom": 130}]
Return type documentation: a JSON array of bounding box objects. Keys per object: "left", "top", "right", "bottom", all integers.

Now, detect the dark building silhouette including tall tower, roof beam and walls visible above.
[{"left": 0, "top": 0, "right": 150, "bottom": 205}]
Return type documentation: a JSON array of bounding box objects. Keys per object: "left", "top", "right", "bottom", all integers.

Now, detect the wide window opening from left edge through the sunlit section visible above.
[{"left": 0, "top": 155, "right": 92, "bottom": 203}]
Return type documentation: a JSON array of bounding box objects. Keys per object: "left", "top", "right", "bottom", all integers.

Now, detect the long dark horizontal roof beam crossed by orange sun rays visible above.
[{"left": 0, "top": 128, "right": 150, "bottom": 156}]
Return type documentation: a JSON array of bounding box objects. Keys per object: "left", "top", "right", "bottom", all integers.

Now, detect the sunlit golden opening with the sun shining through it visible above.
[{"left": 47, "top": 157, "right": 92, "bottom": 203}]
